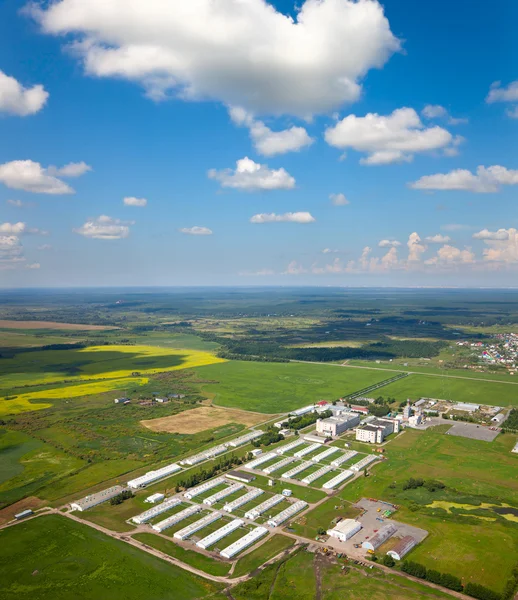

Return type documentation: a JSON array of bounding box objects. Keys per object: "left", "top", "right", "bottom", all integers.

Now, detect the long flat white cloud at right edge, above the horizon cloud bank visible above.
[{"left": 409, "top": 165, "right": 518, "bottom": 194}]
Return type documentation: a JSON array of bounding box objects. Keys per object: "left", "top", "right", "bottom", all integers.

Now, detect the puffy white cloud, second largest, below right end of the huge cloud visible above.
[{"left": 324, "top": 108, "right": 454, "bottom": 165}]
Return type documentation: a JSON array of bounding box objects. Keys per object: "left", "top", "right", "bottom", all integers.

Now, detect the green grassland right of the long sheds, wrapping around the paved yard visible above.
[{"left": 301, "top": 429, "right": 518, "bottom": 592}]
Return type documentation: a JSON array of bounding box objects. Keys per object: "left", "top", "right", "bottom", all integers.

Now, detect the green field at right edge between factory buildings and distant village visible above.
[{"left": 372, "top": 374, "right": 518, "bottom": 406}]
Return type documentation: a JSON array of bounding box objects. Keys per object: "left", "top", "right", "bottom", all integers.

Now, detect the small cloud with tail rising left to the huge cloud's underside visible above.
[{"left": 229, "top": 107, "right": 315, "bottom": 156}]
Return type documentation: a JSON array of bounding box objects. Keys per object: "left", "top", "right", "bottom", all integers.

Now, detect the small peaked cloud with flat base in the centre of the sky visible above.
[{"left": 208, "top": 156, "right": 295, "bottom": 192}]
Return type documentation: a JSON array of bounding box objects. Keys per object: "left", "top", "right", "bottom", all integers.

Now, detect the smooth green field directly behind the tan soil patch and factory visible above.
[{"left": 196, "top": 361, "right": 391, "bottom": 414}]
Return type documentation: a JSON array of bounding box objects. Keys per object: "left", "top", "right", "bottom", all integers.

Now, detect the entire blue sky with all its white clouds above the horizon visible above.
[{"left": 0, "top": 0, "right": 518, "bottom": 287}]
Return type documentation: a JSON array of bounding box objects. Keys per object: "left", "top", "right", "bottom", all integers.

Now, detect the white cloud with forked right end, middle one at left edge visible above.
[{"left": 0, "top": 160, "right": 90, "bottom": 195}]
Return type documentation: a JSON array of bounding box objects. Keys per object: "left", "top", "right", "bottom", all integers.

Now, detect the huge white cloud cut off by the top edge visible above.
[{"left": 29, "top": 0, "right": 400, "bottom": 117}]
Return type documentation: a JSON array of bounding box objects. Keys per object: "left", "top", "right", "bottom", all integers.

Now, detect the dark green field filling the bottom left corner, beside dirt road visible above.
[{"left": 0, "top": 515, "right": 221, "bottom": 600}]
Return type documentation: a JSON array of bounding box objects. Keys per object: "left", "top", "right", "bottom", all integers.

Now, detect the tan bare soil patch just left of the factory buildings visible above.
[{"left": 140, "top": 406, "right": 274, "bottom": 433}]
